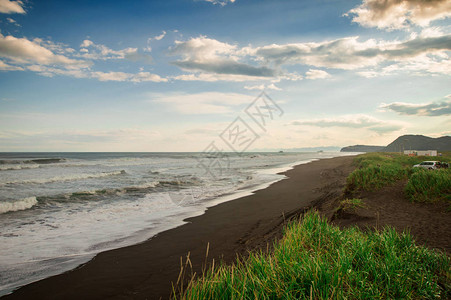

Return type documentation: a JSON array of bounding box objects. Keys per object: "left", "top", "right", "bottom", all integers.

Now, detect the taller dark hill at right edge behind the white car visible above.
[{"left": 382, "top": 135, "right": 451, "bottom": 152}]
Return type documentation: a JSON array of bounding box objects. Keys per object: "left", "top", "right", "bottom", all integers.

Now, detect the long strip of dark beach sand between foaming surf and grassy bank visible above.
[{"left": 2, "top": 156, "right": 353, "bottom": 299}]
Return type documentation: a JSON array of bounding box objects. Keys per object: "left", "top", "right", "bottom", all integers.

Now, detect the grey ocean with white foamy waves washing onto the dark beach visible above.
[{"left": 0, "top": 152, "right": 349, "bottom": 295}]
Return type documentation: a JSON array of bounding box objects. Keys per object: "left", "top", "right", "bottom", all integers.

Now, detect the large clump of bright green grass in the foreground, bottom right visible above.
[{"left": 174, "top": 212, "right": 451, "bottom": 299}]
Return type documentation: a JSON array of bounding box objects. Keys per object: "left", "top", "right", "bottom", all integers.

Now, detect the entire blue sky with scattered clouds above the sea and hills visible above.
[{"left": 0, "top": 0, "right": 451, "bottom": 152}]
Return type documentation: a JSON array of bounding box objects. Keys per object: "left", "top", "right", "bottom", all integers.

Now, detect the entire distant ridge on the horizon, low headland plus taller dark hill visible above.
[{"left": 340, "top": 134, "right": 451, "bottom": 152}]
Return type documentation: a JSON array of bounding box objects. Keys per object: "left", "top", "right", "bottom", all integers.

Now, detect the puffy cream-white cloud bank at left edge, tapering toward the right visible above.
[{"left": 0, "top": 33, "right": 168, "bottom": 82}]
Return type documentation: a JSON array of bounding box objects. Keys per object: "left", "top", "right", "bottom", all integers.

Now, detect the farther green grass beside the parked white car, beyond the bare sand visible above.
[{"left": 345, "top": 152, "right": 451, "bottom": 202}]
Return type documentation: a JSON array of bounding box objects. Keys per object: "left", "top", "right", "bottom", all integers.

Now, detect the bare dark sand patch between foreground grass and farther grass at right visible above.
[{"left": 317, "top": 180, "right": 451, "bottom": 255}]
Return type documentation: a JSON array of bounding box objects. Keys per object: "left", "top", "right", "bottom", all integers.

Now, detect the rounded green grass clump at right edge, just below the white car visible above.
[{"left": 405, "top": 169, "right": 451, "bottom": 204}]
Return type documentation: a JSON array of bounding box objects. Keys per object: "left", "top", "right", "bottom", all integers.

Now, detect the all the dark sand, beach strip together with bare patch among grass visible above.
[{"left": 2, "top": 156, "right": 451, "bottom": 300}]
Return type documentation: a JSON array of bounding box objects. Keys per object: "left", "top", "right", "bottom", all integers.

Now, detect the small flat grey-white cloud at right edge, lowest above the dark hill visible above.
[{"left": 380, "top": 95, "right": 451, "bottom": 117}]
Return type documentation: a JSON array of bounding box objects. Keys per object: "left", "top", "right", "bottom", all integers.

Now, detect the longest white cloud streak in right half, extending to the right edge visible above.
[{"left": 252, "top": 32, "right": 451, "bottom": 76}]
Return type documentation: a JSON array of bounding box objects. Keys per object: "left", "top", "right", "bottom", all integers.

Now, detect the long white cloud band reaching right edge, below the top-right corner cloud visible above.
[{"left": 252, "top": 35, "right": 451, "bottom": 70}]
